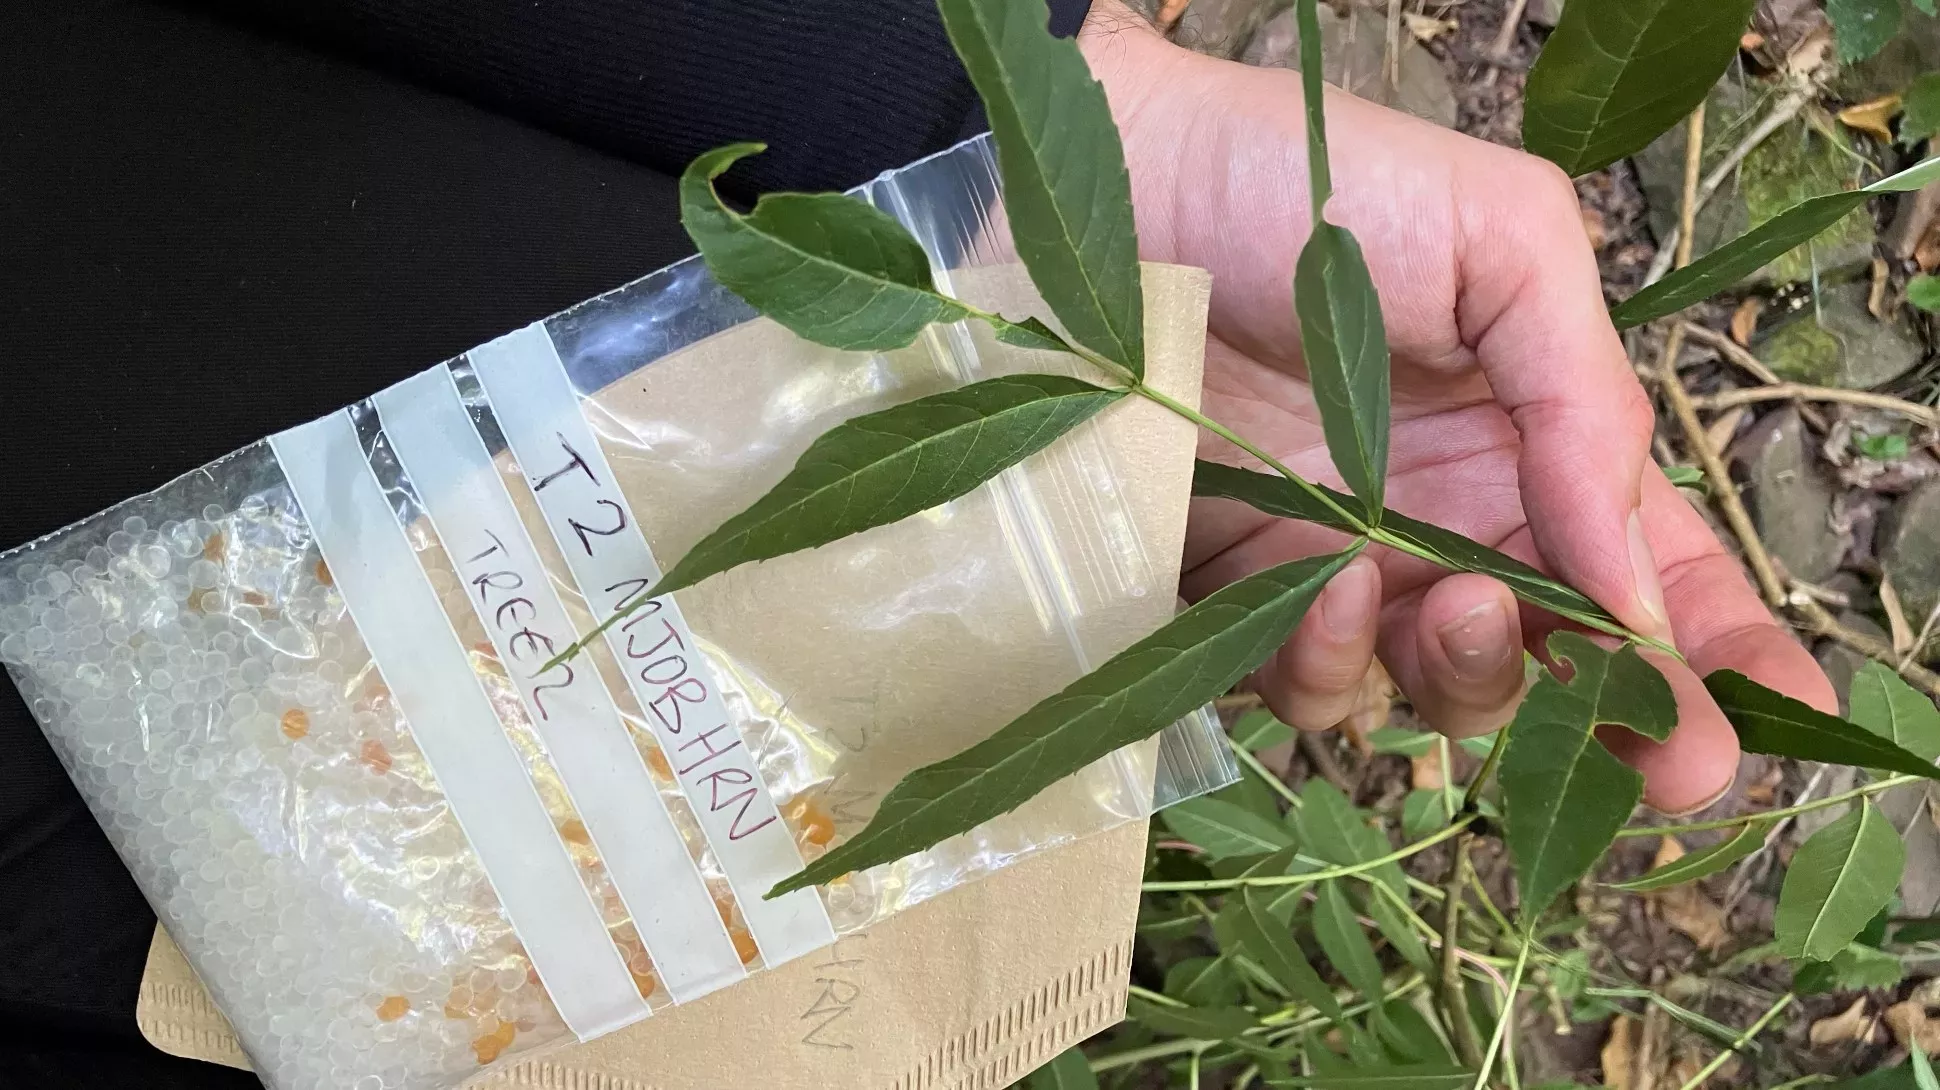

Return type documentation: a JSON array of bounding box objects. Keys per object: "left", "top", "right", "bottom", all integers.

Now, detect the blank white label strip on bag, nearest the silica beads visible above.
[{"left": 270, "top": 411, "right": 648, "bottom": 1040}]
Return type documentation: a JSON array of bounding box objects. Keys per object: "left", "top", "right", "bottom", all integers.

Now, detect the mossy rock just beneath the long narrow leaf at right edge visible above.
[{"left": 1758, "top": 283, "right": 1926, "bottom": 390}]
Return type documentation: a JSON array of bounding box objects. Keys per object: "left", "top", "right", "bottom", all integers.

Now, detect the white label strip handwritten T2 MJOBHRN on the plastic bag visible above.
[{"left": 469, "top": 324, "right": 834, "bottom": 966}]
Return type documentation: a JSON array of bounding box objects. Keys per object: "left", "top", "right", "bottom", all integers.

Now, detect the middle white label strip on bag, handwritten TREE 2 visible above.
[{"left": 372, "top": 367, "right": 747, "bottom": 1003}]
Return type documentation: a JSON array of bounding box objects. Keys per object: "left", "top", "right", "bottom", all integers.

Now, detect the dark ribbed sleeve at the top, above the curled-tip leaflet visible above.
[{"left": 187, "top": 0, "right": 1090, "bottom": 196}]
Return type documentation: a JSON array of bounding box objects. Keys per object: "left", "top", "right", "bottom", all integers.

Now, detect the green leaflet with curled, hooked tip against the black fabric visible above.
[{"left": 681, "top": 144, "right": 970, "bottom": 351}]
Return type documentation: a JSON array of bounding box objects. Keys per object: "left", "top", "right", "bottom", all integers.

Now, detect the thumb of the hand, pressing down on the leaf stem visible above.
[{"left": 1455, "top": 157, "right": 1670, "bottom": 638}]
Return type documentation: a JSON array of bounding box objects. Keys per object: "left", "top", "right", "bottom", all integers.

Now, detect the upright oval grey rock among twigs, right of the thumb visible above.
[{"left": 1738, "top": 409, "right": 1845, "bottom": 582}]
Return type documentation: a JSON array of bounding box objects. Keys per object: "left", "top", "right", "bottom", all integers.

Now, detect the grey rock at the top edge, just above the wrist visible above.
[{"left": 1242, "top": 4, "right": 1455, "bottom": 128}]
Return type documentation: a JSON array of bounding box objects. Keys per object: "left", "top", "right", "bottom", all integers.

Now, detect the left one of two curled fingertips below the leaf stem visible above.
[{"left": 1257, "top": 557, "right": 1381, "bottom": 731}]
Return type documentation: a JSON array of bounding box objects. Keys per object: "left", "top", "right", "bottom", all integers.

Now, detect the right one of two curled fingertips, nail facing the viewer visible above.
[{"left": 1381, "top": 574, "right": 1523, "bottom": 739}]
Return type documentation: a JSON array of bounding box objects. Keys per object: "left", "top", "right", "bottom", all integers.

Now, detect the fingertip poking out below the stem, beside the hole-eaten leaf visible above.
[{"left": 1597, "top": 652, "right": 1738, "bottom": 817}]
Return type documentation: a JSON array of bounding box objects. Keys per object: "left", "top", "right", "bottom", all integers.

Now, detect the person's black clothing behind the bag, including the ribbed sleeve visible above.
[{"left": 0, "top": 0, "right": 1084, "bottom": 1090}]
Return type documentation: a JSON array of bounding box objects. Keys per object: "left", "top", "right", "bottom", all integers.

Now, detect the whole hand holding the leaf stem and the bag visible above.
[{"left": 1081, "top": 0, "right": 1835, "bottom": 813}]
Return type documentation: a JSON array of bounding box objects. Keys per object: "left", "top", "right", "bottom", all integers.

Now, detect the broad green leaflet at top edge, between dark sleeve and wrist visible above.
[{"left": 937, "top": 0, "right": 1145, "bottom": 376}]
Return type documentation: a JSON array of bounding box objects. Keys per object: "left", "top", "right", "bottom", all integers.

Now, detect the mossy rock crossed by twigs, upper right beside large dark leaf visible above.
[{"left": 1632, "top": 76, "right": 1872, "bottom": 283}]
